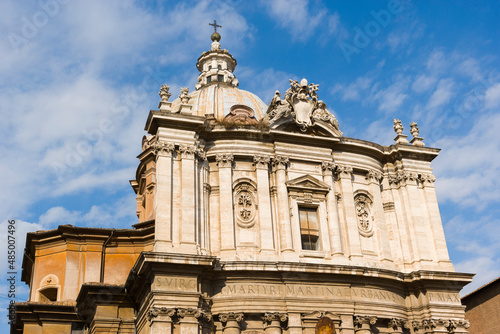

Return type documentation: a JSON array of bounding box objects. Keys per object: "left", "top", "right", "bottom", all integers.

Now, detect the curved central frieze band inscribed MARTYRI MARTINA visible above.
[{"left": 215, "top": 283, "right": 404, "bottom": 305}]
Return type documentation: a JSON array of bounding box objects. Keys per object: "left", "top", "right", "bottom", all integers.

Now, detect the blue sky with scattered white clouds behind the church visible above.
[{"left": 0, "top": 0, "right": 500, "bottom": 321}]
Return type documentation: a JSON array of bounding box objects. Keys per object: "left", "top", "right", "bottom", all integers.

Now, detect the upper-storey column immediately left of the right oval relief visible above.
[{"left": 336, "top": 165, "right": 362, "bottom": 259}]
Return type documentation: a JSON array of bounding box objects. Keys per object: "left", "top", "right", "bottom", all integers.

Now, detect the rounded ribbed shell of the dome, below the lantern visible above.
[{"left": 172, "top": 84, "right": 267, "bottom": 120}]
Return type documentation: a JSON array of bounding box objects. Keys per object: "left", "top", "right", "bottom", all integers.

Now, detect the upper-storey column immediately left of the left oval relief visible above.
[{"left": 215, "top": 154, "right": 236, "bottom": 252}]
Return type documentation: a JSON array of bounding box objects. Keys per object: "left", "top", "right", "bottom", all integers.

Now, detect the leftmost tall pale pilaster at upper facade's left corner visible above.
[{"left": 153, "top": 140, "right": 175, "bottom": 252}]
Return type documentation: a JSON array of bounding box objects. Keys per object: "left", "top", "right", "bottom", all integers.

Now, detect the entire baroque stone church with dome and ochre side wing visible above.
[{"left": 14, "top": 33, "right": 472, "bottom": 334}]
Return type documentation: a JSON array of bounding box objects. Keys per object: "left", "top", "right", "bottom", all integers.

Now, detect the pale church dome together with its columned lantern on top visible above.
[{"left": 167, "top": 34, "right": 267, "bottom": 121}]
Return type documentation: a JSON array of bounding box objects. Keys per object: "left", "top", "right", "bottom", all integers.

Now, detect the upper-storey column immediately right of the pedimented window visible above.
[{"left": 321, "top": 161, "right": 344, "bottom": 256}]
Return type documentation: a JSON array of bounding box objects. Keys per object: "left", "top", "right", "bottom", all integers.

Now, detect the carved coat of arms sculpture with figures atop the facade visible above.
[{"left": 267, "top": 79, "right": 338, "bottom": 132}]
